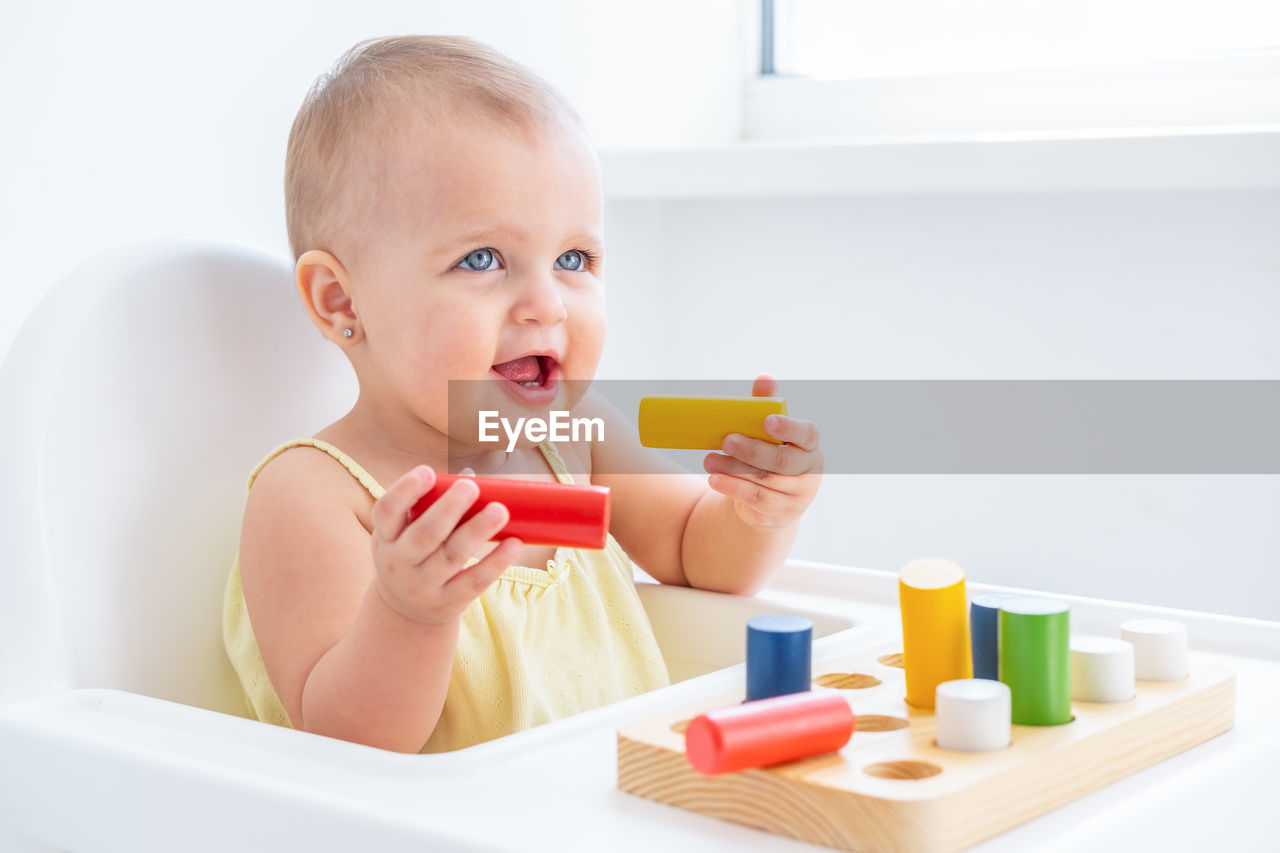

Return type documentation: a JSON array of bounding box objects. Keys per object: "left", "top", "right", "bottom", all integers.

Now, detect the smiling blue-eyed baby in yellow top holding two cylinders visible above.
[{"left": 224, "top": 37, "right": 822, "bottom": 752}]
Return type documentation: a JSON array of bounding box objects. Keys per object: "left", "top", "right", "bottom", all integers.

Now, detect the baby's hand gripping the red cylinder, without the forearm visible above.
[{"left": 372, "top": 465, "right": 522, "bottom": 625}]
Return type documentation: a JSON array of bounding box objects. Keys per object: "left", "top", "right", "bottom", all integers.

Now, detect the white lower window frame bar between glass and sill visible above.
[{"left": 744, "top": 51, "right": 1280, "bottom": 140}]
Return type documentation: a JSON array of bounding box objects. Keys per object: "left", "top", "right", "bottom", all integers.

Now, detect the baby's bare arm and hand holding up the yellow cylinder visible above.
[{"left": 590, "top": 377, "right": 822, "bottom": 594}]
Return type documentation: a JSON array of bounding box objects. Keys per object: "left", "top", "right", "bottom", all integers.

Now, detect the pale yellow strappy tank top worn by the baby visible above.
[{"left": 223, "top": 439, "right": 669, "bottom": 752}]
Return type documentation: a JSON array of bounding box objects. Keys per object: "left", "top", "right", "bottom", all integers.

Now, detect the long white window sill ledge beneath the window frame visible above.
[{"left": 600, "top": 124, "right": 1280, "bottom": 201}]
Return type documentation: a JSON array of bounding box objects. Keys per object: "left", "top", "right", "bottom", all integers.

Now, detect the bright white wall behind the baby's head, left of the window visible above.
[{"left": 0, "top": 0, "right": 746, "bottom": 355}]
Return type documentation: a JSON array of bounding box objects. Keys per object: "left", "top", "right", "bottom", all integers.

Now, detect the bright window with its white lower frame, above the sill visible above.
[{"left": 746, "top": 0, "right": 1280, "bottom": 140}]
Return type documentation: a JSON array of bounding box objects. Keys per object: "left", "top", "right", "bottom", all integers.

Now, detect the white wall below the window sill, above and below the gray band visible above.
[{"left": 602, "top": 192, "right": 1280, "bottom": 620}]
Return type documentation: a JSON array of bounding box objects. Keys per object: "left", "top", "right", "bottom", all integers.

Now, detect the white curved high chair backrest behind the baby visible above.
[{"left": 0, "top": 243, "right": 355, "bottom": 713}]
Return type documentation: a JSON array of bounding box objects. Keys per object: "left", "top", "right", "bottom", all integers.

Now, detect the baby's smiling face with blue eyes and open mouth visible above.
[{"left": 349, "top": 114, "right": 604, "bottom": 438}]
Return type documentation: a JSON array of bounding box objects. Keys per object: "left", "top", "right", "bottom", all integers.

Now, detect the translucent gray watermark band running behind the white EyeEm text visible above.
[{"left": 449, "top": 379, "right": 1280, "bottom": 475}]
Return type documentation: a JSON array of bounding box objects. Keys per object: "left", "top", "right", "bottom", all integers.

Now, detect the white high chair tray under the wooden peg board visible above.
[{"left": 0, "top": 562, "right": 1280, "bottom": 853}]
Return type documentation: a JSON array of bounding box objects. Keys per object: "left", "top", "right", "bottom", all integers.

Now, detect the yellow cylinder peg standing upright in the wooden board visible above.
[{"left": 897, "top": 558, "right": 973, "bottom": 708}]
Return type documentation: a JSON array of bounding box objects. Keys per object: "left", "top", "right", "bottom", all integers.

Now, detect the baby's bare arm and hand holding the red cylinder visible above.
[{"left": 241, "top": 451, "right": 520, "bottom": 752}]
